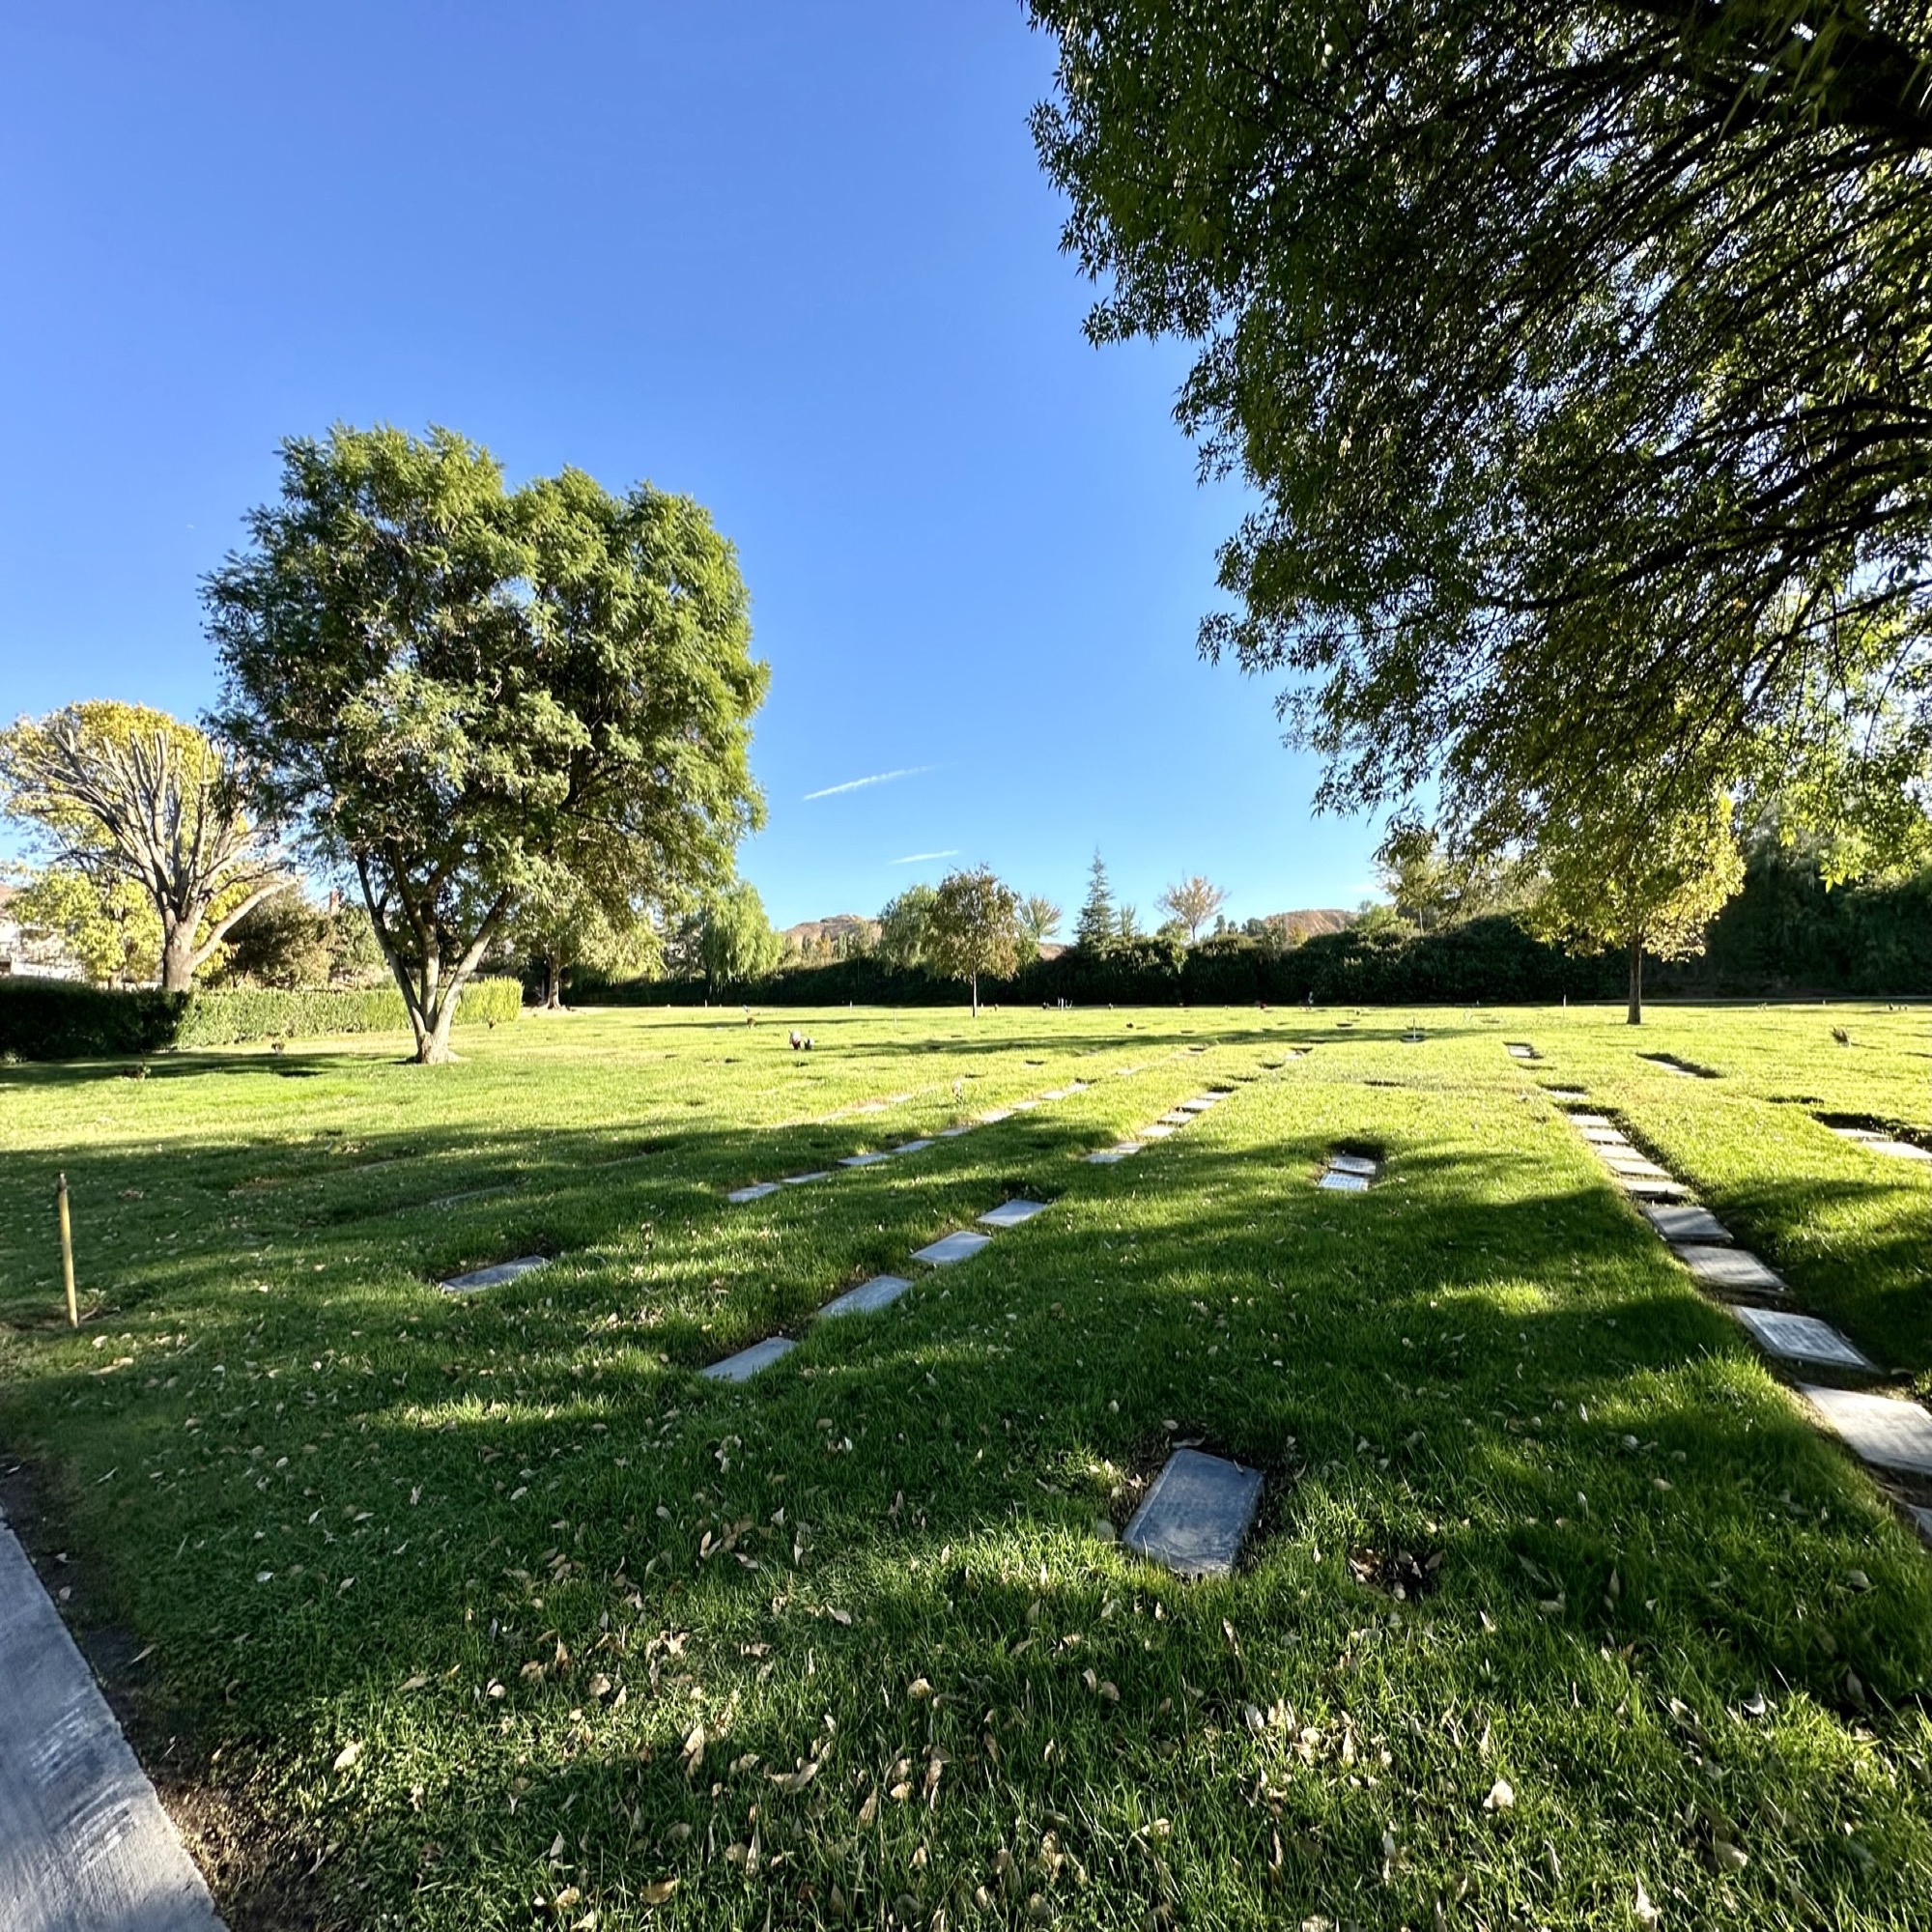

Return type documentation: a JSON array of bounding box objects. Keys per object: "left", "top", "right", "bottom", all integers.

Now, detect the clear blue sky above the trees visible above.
[{"left": 0, "top": 0, "right": 1374, "bottom": 923}]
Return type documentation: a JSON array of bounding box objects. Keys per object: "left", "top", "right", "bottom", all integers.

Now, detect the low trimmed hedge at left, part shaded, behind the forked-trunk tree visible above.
[{"left": 0, "top": 980, "right": 524, "bottom": 1061}]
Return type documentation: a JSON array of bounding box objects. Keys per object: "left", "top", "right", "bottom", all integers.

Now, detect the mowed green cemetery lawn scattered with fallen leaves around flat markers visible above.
[{"left": 0, "top": 1007, "right": 1932, "bottom": 1928}]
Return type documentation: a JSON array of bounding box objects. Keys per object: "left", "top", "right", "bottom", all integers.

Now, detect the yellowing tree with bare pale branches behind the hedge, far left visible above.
[{"left": 0, "top": 701, "right": 294, "bottom": 993}]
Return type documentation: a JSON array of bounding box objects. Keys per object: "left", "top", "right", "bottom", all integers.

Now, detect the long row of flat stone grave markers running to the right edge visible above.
[{"left": 1548, "top": 1088, "right": 1932, "bottom": 1542}]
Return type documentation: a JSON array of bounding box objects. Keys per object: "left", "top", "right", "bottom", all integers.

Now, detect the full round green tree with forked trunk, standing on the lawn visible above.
[{"left": 205, "top": 427, "right": 765, "bottom": 1061}]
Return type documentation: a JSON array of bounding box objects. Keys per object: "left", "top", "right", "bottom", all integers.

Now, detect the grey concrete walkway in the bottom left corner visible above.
[{"left": 0, "top": 1517, "right": 222, "bottom": 1932}]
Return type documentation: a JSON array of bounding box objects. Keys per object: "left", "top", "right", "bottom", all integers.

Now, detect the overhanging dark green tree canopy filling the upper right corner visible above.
[{"left": 1032, "top": 0, "right": 1932, "bottom": 848}]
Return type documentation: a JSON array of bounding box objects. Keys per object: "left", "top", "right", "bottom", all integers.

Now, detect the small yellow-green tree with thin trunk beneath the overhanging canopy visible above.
[{"left": 1530, "top": 779, "right": 1745, "bottom": 1026}]
